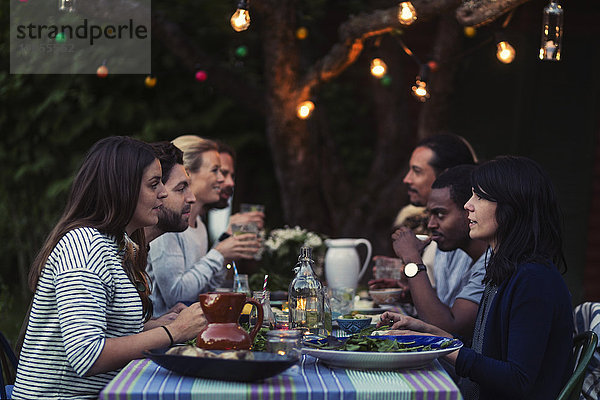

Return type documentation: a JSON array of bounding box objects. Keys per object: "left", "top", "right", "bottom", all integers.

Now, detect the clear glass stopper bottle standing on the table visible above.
[{"left": 288, "top": 246, "right": 323, "bottom": 335}]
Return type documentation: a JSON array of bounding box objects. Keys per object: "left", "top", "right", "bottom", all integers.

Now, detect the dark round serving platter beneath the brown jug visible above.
[{"left": 145, "top": 349, "right": 298, "bottom": 382}]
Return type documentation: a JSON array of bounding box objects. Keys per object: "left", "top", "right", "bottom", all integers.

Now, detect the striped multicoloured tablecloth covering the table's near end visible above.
[{"left": 100, "top": 355, "right": 462, "bottom": 400}]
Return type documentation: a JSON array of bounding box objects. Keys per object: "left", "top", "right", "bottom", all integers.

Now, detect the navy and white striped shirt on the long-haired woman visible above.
[{"left": 13, "top": 228, "right": 143, "bottom": 399}]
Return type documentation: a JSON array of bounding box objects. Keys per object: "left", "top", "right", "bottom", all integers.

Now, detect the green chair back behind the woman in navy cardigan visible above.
[{"left": 557, "top": 331, "right": 598, "bottom": 400}]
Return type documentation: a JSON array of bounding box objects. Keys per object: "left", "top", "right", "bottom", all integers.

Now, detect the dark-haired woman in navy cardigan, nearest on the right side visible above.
[{"left": 383, "top": 156, "right": 573, "bottom": 399}]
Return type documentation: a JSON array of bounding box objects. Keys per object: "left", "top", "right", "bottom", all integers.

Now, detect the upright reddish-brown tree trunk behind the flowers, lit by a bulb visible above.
[{"left": 263, "top": 1, "right": 332, "bottom": 231}]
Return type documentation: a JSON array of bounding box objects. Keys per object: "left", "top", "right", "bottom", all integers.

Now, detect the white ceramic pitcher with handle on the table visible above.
[{"left": 325, "top": 239, "right": 372, "bottom": 289}]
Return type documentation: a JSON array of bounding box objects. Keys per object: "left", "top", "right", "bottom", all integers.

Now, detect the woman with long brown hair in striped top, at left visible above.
[{"left": 13, "top": 137, "right": 204, "bottom": 399}]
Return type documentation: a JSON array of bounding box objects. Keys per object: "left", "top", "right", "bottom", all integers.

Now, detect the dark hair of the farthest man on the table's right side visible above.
[{"left": 416, "top": 133, "right": 476, "bottom": 176}]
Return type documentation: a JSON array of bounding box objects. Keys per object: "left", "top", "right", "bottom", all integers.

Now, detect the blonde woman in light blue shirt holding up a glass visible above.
[{"left": 147, "top": 135, "right": 260, "bottom": 317}]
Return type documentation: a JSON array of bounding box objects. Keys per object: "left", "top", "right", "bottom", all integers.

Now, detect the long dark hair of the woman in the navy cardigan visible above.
[{"left": 471, "top": 156, "right": 566, "bottom": 284}]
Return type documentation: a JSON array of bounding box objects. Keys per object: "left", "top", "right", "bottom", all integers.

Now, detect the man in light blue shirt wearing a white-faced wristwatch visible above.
[{"left": 378, "top": 165, "right": 487, "bottom": 338}]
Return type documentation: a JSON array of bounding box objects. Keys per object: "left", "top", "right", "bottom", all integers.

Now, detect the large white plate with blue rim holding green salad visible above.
[{"left": 302, "top": 336, "right": 463, "bottom": 370}]
